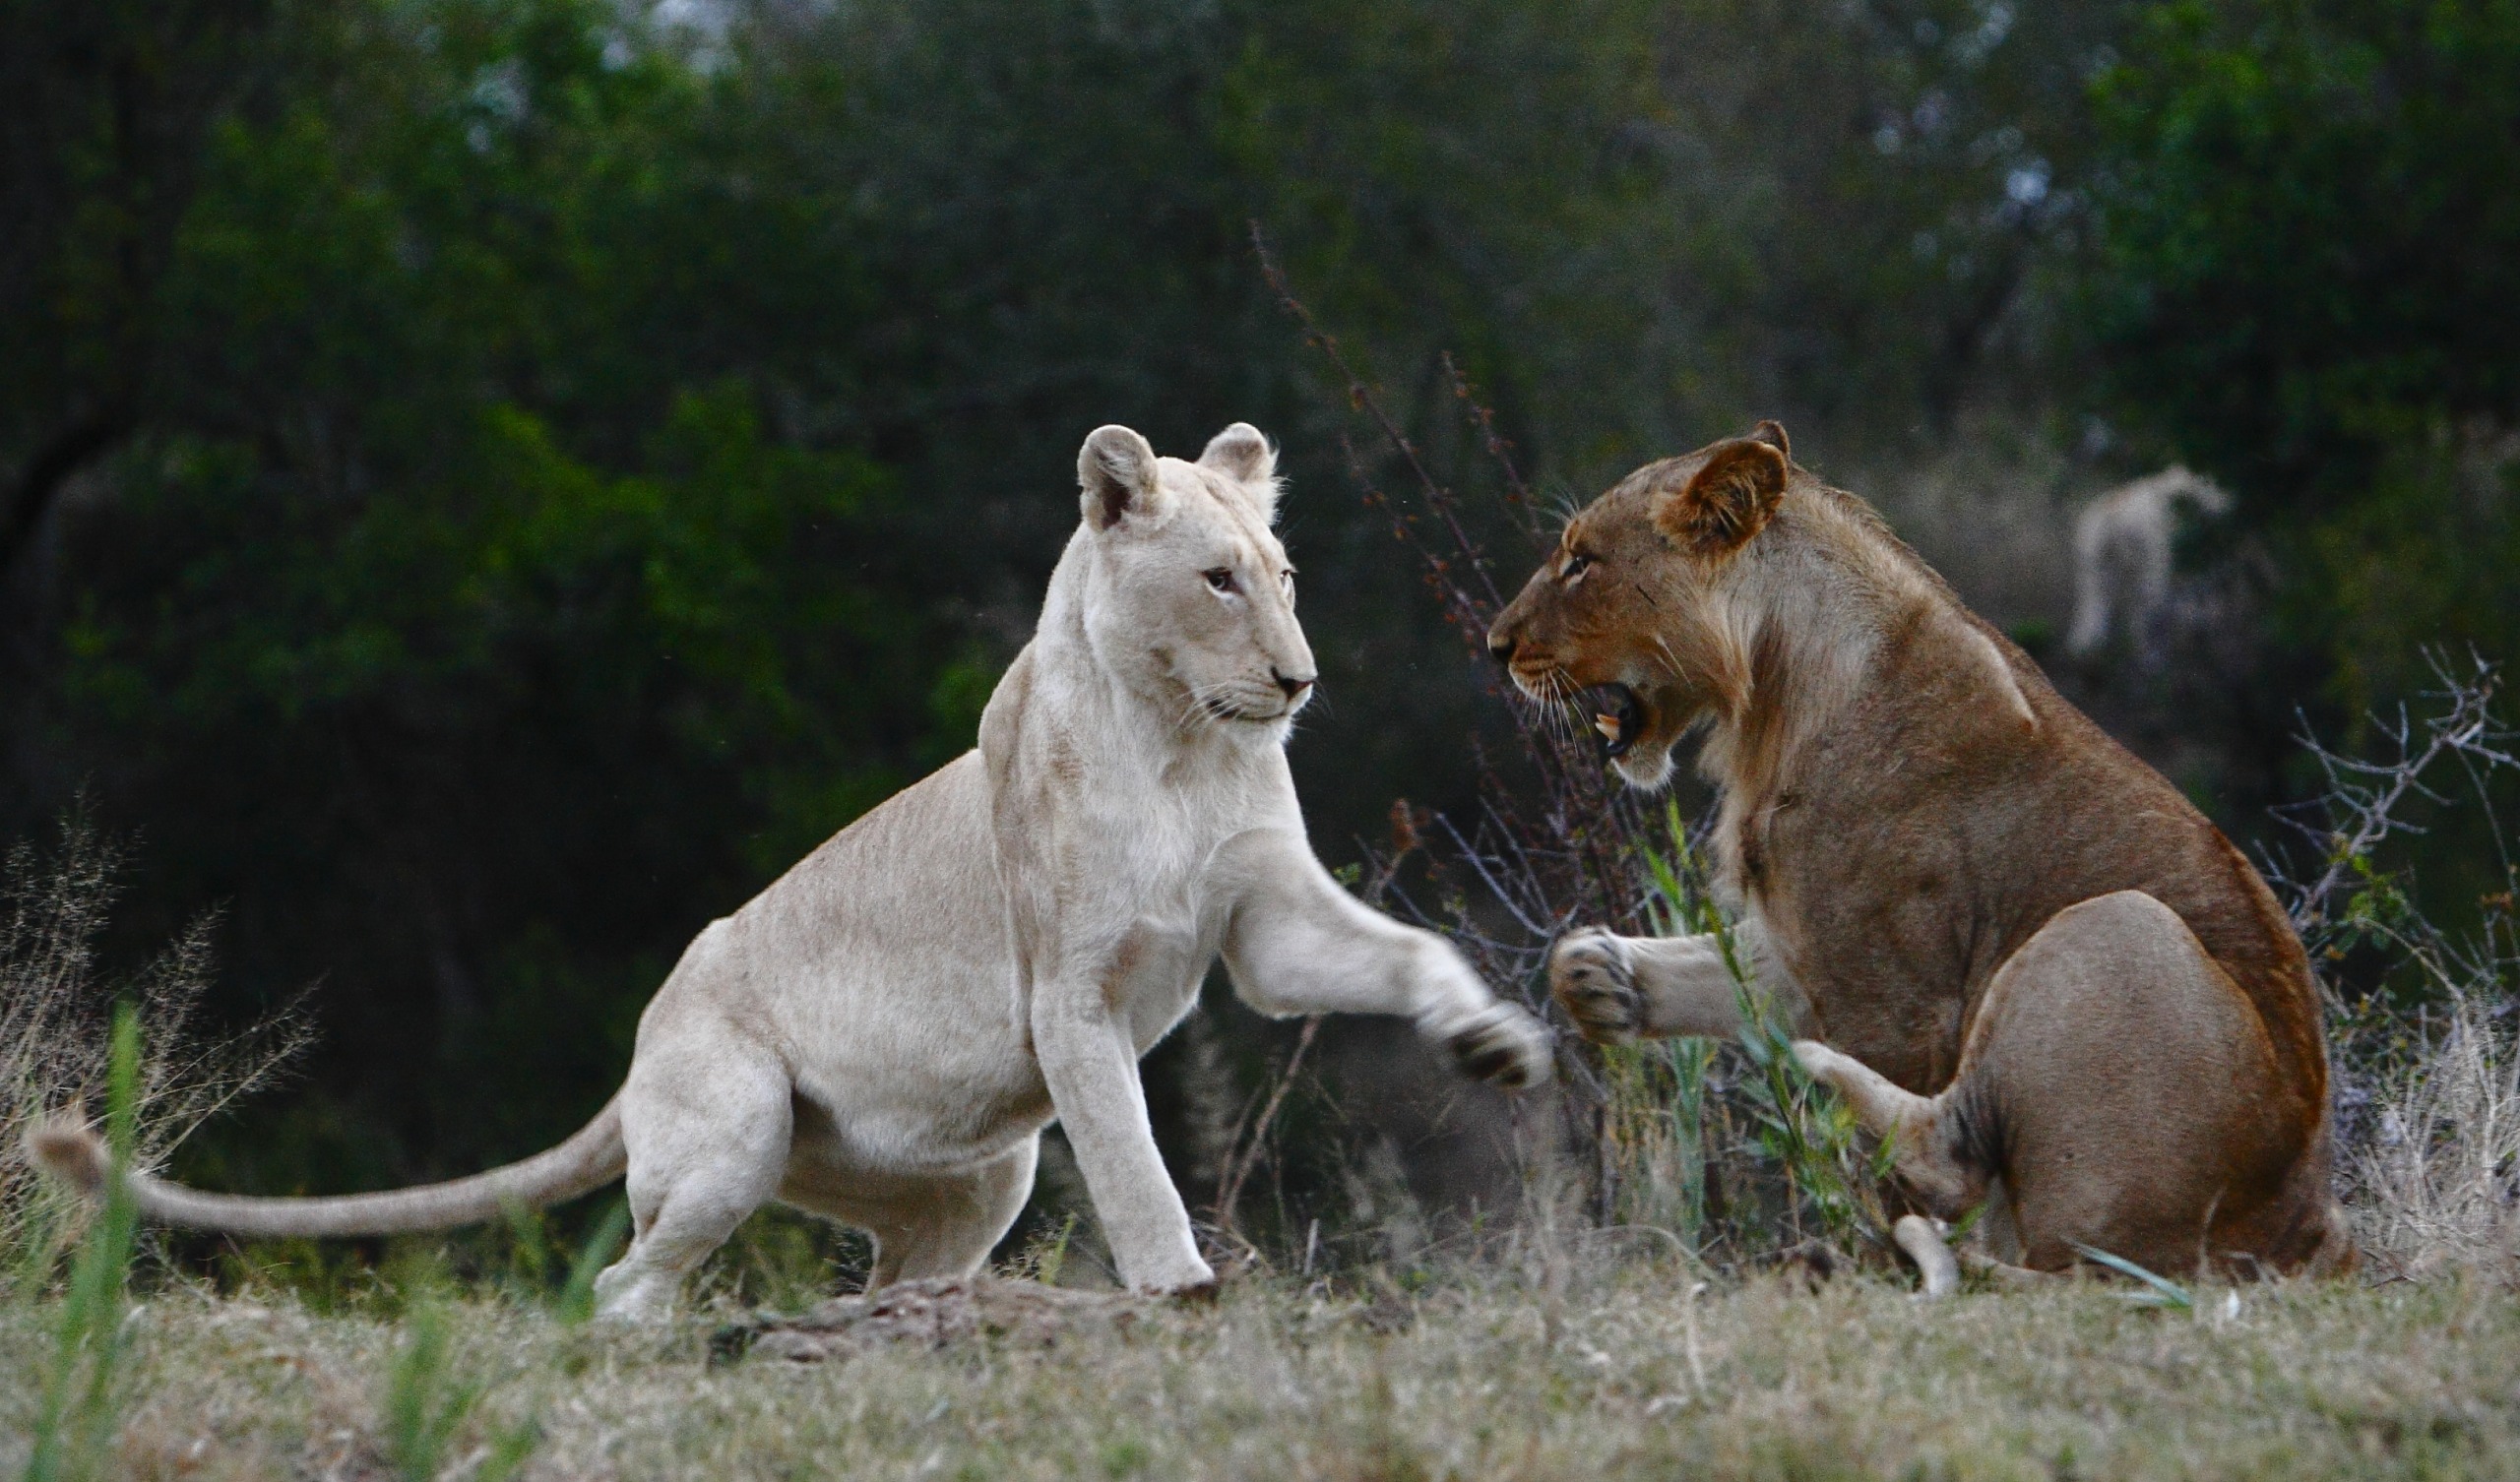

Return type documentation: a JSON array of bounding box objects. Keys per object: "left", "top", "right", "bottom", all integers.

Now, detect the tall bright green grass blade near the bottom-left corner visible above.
[{"left": 26, "top": 1006, "right": 141, "bottom": 1482}]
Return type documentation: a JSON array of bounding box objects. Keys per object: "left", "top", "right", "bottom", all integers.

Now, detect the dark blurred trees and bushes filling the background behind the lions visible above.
[{"left": 0, "top": 0, "right": 2520, "bottom": 1255}]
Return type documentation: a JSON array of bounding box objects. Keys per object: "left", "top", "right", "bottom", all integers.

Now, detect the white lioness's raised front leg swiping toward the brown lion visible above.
[{"left": 1217, "top": 830, "right": 1549, "bottom": 1088}]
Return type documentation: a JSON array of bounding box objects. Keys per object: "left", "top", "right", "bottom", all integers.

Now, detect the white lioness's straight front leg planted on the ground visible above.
[{"left": 1034, "top": 975, "right": 1217, "bottom": 1293}]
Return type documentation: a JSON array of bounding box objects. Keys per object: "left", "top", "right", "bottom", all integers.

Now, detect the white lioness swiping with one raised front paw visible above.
[{"left": 35, "top": 423, "right": 1549, "bottom": 1316}]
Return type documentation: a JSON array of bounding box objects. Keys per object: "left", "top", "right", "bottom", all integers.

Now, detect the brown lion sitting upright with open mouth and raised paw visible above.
[{"left": 1489, "top": 423, "right": 2351, "bottom": 1288}]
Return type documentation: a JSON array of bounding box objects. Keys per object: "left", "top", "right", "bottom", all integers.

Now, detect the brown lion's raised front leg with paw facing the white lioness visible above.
[{"left": 1549, "top": 917, "right": 1799, "bottom": 1043}]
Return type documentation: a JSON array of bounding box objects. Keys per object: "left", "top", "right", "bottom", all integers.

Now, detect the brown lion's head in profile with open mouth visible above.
[{"left": 1486, "top": 421, "right": 1792, "bottom": 786}]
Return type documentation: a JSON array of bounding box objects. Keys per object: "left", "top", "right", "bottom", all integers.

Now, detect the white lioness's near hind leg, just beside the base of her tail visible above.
[{"left": 595, "top": 1036, "right": 791, "bottom": 1321}]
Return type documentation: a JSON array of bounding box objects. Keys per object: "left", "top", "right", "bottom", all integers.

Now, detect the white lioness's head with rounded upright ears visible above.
[{"left": 1071, "top": 421, "right": 1315, "bottom": 736}]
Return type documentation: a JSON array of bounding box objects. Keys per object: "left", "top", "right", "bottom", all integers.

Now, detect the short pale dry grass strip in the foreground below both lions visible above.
[{"left": 0, "top": 1263, "right": 2520, "bottom": 1479}]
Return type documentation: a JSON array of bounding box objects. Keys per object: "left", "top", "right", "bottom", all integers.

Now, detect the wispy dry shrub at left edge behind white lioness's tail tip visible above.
[{"left": 0, "top": 812, "right": 312, "bottom": 1283}]
